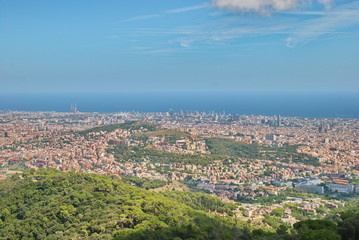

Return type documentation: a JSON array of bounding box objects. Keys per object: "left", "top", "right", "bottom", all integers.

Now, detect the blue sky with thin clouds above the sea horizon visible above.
[{"left": 0, "top": 0, "right": 359, "bottom": 93}]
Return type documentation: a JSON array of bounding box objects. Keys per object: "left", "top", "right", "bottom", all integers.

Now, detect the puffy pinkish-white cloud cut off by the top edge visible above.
[{"left": 213, "top": 0, "right": 332, "bottom": 13}]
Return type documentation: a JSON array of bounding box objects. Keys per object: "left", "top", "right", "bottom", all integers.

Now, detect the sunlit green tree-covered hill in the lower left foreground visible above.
[{"left": 0, "top": 169, "right": 250, "bottom": 239}]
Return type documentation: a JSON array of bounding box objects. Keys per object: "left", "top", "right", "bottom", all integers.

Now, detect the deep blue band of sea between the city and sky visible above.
[{"left": 0, "top": 92, "right": 359, "bottom": 118}]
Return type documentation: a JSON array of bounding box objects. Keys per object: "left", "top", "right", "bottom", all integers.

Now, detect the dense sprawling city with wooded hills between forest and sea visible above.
[{"left": 0, "top": 109, "right": 359, "bottom": 229}]
